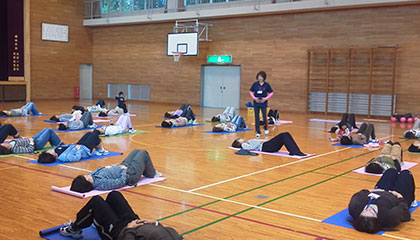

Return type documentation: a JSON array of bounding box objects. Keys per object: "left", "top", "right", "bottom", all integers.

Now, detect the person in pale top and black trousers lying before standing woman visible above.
[{"left": 232, "top": 132, "right": 307, "bottom": 156}]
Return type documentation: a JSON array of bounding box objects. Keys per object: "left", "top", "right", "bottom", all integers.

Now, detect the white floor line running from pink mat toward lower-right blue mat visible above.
[{"left": 149, "top": 183, "right": 322, "bottom": 222}]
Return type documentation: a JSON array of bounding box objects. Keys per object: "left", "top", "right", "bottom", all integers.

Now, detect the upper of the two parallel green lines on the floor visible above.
[{"left": 158, "top": 147, "right": 378, "bottom": 221}]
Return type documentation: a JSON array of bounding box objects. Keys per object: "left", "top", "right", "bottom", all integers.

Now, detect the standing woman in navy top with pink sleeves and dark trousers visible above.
[{"left": 249, "top": 71, "right": 274, "bottom": 137}]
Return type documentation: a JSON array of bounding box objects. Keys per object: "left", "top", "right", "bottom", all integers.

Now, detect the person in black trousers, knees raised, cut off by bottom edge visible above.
[{"left": 60, "top": 191, "right": 183, "bottom": 240}]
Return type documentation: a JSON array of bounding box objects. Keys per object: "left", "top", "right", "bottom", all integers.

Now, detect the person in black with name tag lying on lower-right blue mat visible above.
[{"left": 348, "top": 168, "right": 417, "bottom": 233}]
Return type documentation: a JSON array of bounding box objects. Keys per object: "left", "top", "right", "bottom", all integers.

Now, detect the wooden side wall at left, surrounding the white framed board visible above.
[{"left": 30, "top": 0, "right": 93, "bottom": 100}]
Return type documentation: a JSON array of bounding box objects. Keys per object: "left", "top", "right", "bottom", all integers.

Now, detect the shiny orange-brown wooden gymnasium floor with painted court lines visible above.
[{"left": 0, "top": 101, "right": 420, "bottom": 240}]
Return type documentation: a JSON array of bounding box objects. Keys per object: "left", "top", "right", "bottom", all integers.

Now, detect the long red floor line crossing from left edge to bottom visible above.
[{"left": 0, "top": 161, "right": 332, "bottom": 240}]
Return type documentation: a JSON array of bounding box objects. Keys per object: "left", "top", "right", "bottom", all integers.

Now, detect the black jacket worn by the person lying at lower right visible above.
[{"left": 349, "top": 189, "right": 410, "bottom": 228}]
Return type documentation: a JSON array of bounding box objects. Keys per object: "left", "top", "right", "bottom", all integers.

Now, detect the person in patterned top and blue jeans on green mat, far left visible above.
[{"left": 0, "top": 128, "right": 62, "bottom": 155}]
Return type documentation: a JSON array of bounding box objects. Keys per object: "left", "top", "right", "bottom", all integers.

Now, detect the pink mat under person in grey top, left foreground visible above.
[{"left": 51, "top": 177, "right": 166, "bottom": 198}]
